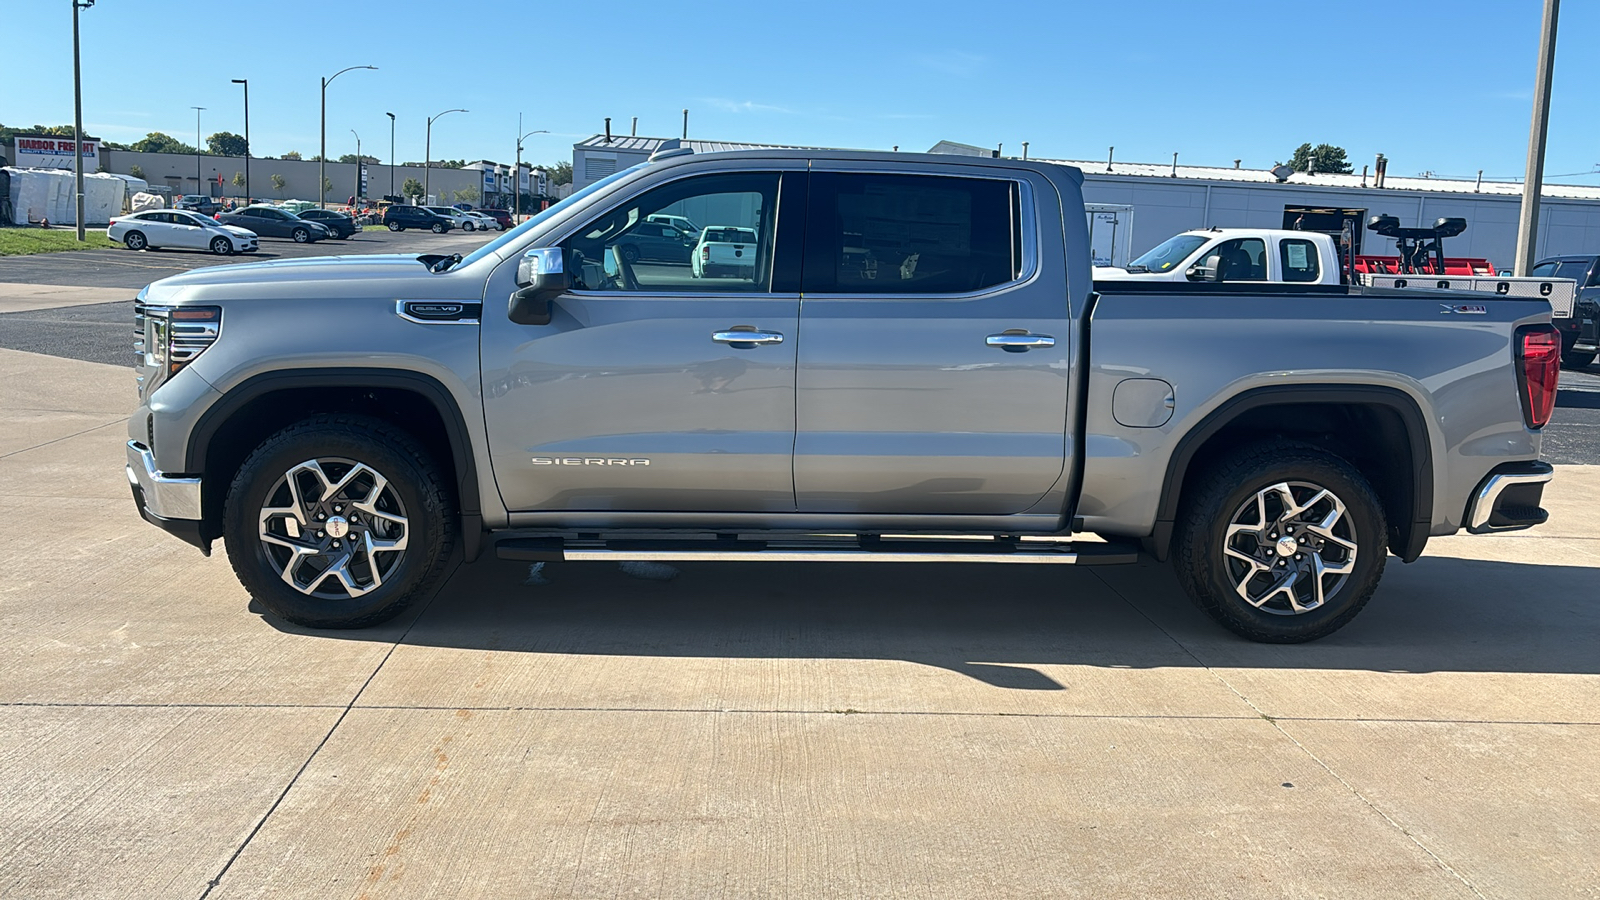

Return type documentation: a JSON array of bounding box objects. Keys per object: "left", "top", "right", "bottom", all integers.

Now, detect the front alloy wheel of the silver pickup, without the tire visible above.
[{"left": 259, "top": 456, "right": 410, "bottom": 601}]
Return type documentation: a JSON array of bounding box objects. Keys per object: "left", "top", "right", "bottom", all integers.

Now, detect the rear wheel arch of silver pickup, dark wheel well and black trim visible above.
[{"left": 1149, "top": 384, "right": 1434, "bottom": 562}]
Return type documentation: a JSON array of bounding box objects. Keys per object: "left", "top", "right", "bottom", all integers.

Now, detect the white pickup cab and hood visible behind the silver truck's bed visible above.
[{"left": 1094, "top": 227, "right": 1339, "bottom": 285}]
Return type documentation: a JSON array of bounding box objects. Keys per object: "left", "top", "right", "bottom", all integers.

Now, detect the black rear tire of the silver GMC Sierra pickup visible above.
[{"left": 1173, "top": 442, "right": 1389, "bottom": 644}]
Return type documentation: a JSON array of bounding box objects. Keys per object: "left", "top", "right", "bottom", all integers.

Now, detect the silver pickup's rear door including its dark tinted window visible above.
[{"left": 794, "top": 163, "right": 1070, "bottom": 516}]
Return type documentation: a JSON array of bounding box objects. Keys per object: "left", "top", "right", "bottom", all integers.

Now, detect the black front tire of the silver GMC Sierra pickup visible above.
[{"left": 224, "top": 413, "right": 456, "bottom": 628}]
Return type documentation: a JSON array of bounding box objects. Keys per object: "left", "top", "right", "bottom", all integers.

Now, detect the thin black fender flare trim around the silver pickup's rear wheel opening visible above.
[{"left": 1149, "top": 384, "right": 1434, "bottom": 562}]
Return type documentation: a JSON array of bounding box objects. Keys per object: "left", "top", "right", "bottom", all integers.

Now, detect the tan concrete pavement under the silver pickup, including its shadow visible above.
[{"left": 0, "top": 344, "right": 1600, "bottom": 898}]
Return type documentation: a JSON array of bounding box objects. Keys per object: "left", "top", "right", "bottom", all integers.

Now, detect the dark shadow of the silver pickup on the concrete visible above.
[{"left": 253, "top": 541, "right": 1600, "bottom": 690}]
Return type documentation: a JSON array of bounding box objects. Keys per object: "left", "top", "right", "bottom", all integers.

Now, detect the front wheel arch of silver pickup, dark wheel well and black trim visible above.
[{"left": 187, "top": 368, "right": 483, "bottom": 560}]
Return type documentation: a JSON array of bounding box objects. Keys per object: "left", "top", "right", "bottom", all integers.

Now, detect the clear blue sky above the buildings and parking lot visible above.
[{"left": 0, "top": 0, "right": 1600, "bottom": 184}]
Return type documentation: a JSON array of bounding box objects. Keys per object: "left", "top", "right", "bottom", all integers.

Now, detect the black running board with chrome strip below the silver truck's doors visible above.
[{"left": 494, "top": 538, "right": 1139, "bottom": 565}]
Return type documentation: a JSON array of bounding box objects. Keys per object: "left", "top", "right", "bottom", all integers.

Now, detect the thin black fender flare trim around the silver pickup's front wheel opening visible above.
[{"left": 186, "top": 367, "right": 483, "bottom": 562}]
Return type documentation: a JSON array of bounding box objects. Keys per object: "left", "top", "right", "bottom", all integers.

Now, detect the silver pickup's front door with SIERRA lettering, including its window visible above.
[{"left": 482, "top": 168, "right": 805, "bottom": 512}]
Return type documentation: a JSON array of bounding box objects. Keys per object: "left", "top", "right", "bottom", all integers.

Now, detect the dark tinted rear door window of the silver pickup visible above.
[{"left": 806, "top": 171, "right": 1022, "bottom": 295}]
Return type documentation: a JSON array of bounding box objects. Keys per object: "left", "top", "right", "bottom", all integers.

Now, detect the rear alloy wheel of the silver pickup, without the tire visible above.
[{"left": 1222, "top": 482, "right": 1357, "bottom": 615}]
